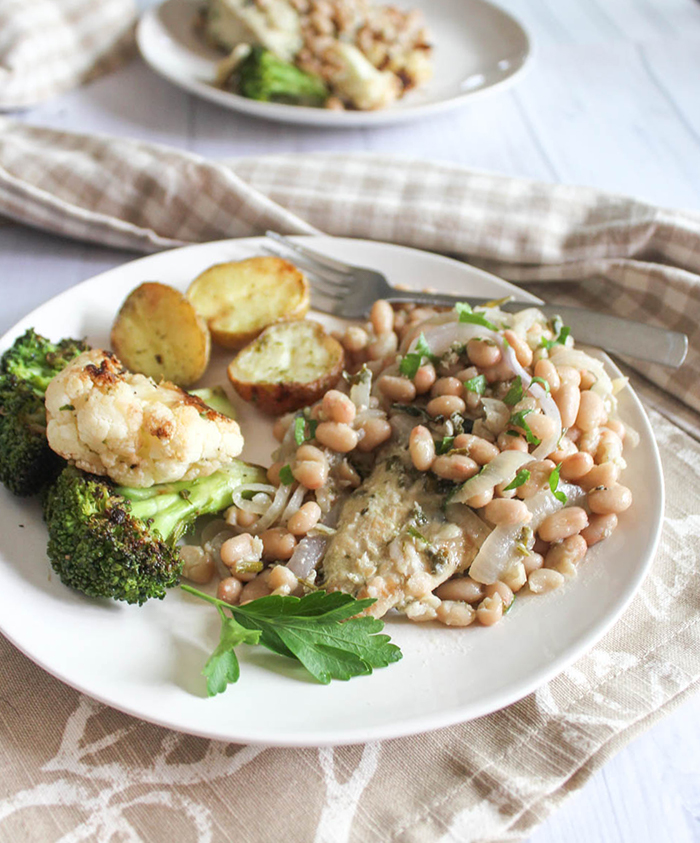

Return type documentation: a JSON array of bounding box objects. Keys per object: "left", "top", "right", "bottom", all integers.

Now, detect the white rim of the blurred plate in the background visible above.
[{"left": 136, "top": 0, "right": 534, "bottom": 129}]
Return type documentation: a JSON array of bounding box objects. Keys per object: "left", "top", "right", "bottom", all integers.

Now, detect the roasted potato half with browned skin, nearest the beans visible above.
[{"left": 228, "top": 319, "right": 344, "bottom": 415}]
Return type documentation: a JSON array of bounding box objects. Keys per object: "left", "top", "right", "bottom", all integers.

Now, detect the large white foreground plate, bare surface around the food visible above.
[{"left": 0, "top": 238, "right": 663, "bottom": 746}]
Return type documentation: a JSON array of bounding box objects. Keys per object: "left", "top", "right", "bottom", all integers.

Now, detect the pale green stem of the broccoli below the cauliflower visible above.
[{"left": 115, "top": 460, "right": 265, "bottom": 543}]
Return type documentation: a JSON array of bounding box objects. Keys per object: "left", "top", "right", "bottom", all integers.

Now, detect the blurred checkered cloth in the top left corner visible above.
[{"left": 0, "top": 0, "right": 136, "bottom": 111}]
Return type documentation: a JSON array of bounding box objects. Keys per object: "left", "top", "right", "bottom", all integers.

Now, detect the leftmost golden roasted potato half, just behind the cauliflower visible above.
[{"left": 112, "top": 281, "right": 211, "bottom": 387}]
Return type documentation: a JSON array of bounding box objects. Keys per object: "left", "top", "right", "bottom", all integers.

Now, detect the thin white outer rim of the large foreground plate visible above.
[{"left": 0, "top": 235, "right": 665, "bottom": 747}]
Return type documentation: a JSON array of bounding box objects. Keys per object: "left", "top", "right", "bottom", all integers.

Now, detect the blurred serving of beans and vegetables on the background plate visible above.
[{"left": 203, "top": 0, "right": 432, "bottom": 111}]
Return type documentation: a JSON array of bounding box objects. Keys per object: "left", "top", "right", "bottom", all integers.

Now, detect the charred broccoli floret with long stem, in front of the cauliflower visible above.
[{"left": 44, "top": 460, "right": 265, "bottom": 605}]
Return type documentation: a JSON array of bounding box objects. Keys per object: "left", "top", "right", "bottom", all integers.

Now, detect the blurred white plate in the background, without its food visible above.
[{"left": 137, "top": 0, "right": 531, "bottom": 127}]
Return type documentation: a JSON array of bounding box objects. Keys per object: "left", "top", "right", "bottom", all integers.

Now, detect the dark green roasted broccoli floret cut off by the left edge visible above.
[{"left": 0, "top": 329, "right": 87, "bottom": 495}]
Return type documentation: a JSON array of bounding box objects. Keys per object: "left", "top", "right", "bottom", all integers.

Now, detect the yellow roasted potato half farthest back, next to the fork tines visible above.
[{"left": 187, "top": 257, "right": 311, "bottom": 348}]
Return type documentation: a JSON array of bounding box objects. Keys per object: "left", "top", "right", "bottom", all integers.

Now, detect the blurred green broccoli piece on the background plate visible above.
[{"left": 230, "top": 47, "right": 328, "bottom": 106}]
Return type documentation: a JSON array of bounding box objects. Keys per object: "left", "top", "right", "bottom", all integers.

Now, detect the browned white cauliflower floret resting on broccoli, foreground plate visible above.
[{"left": 46, "top": 349, "right": 243, "bottom": 487}]
